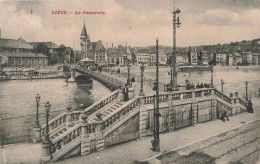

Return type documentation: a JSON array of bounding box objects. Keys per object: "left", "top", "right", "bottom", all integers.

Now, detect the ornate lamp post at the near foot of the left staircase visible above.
[{"left": 42, "top": 101, "right": 51, "bottom": 161}]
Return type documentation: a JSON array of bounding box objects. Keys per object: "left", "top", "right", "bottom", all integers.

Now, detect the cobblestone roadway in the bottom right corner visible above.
[{"left": 150, "top": 120, "right": 260, "bottom": 164}]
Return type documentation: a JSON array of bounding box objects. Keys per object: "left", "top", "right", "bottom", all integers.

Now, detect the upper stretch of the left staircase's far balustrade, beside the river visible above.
[{"left": 85, "top": 90, "right": 119, "bottom": 115}]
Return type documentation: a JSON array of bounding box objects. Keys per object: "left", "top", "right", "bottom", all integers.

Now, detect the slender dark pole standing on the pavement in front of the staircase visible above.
[{"left": 152, "top": 39, "right": 160, "bottom": 152}]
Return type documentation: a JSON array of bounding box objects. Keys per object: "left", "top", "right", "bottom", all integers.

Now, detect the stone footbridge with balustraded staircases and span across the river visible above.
[{"left": 34, "top": 68, "right": 247, "bottom": 161}]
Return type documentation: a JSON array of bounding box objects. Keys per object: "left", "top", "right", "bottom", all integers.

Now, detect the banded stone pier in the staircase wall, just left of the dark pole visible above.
[{"left": 139, "top": 105, "right": 148, "bottom": 139}]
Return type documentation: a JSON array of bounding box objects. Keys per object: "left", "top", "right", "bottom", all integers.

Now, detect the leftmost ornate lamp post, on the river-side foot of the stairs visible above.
[{"left": 33, "top": 94, "right": 41, "bottom": 143}]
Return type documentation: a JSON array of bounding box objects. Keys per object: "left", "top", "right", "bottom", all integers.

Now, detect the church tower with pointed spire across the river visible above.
[{"left": 80, "top": 21, "right": 90, "bottom": 58}]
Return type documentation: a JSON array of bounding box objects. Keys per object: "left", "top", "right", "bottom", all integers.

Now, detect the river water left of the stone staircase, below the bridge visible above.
[{"left": 0, "top": 79, "right": 110, "bottom": 144}]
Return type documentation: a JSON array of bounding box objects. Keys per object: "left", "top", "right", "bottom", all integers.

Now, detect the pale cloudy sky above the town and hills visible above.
[{"left": 0, "top": 0, "right": 260, "bottom": 49}]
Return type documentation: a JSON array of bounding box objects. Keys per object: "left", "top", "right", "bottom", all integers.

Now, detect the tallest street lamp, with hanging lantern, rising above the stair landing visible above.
[{"left": 170, "top": 7, "right": 181, "bottom": 90}]
